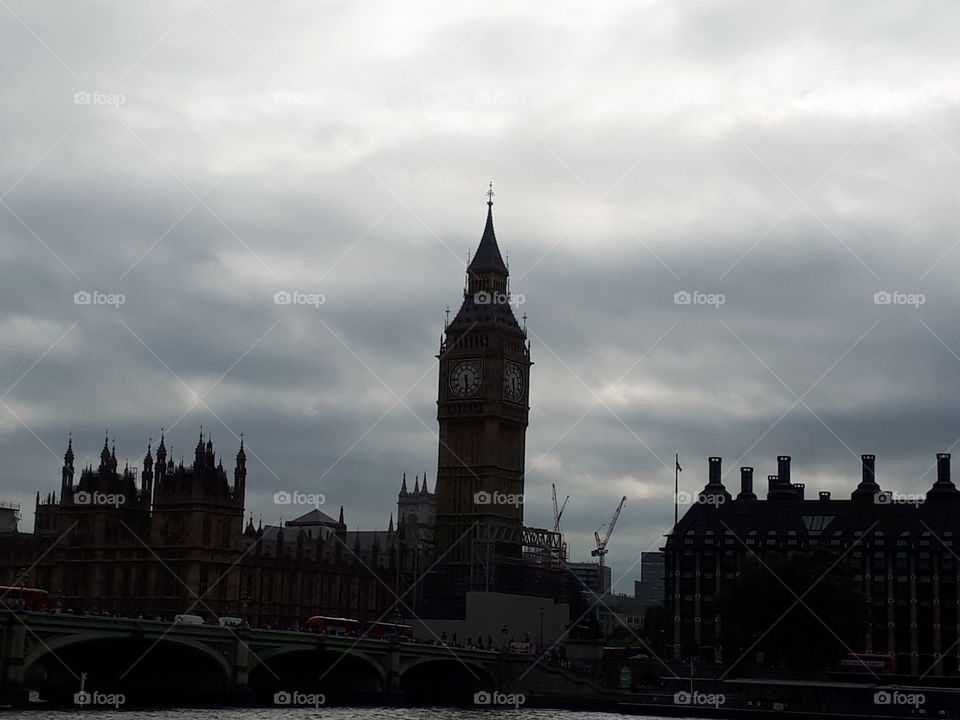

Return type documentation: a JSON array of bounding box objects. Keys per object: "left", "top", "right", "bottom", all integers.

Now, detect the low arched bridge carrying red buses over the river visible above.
[{"left": 0, "top": 610, "right": 504, "bottom": 703}]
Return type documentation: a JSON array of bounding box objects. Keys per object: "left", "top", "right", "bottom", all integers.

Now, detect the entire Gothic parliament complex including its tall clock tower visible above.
[{"left": 0, "top": 191, "right": 568, "bottom": 633}]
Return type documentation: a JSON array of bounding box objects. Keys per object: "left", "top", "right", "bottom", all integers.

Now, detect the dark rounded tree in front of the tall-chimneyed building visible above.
[{"left": 720, "top": 549, "right": 869, "bottom": 670}]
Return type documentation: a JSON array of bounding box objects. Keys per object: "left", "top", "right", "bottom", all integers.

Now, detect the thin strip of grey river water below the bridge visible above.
[{"left": 0, "top": 707, "right": 647, "bottom": 720}]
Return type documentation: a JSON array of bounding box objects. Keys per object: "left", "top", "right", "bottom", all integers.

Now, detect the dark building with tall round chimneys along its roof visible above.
[{"left": 663, "top": 453, "right": 960, "bottom": 675}]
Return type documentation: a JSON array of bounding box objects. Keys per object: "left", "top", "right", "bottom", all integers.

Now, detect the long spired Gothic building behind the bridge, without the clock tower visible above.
[{"left": 0, "top": 435, "right": 395, "bottom": 627}]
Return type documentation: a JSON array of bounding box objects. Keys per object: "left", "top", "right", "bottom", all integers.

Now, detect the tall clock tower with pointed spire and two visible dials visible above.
[{"left": 435, "top": 189, "right": 531, "bottom": 565}]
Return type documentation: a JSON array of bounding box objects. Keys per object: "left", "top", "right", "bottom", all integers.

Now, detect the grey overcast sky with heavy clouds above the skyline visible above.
[{"left": 0, "top": 0, "right": 960, "bottom": 591}]
